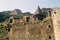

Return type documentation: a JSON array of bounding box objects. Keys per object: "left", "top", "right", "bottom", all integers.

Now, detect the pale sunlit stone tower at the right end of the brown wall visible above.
[{"left": 52, "top": 8, "right": 60, "bottom": 40}]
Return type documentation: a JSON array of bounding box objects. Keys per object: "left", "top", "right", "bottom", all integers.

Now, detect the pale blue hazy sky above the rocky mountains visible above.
[{"left": 0, "top": 0, "right": 60, "bottom": 12}]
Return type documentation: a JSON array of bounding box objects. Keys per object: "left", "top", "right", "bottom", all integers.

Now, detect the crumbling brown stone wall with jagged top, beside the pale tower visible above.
[{"left": 7, "top": 17, "right": 55, "bottom": 40}]
